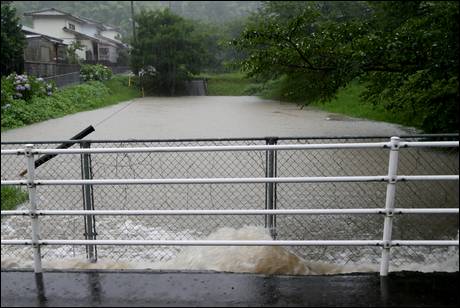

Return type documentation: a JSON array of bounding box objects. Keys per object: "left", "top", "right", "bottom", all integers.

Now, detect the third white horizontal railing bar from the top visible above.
[{"left": 1, "top": 208, "right": 459, "bottom": 216}]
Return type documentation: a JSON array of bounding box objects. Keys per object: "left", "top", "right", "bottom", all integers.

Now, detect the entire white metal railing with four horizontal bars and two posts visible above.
[{"left": 1, "top": 137, "right": 459, "bottom": 276}]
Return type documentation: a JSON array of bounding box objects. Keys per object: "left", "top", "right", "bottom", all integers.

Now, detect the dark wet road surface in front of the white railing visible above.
[{"left": 1, "top": 271, "right": 459, "bottom": 307}]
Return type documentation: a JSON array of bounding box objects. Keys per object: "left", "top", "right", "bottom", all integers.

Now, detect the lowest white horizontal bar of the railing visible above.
[{"left": 1, "top": 239, "right": 459, "bottom": 246}]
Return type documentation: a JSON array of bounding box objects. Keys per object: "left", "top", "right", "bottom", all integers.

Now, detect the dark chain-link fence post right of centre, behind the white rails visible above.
[{"left": 265, "top": 137, "right": 278, "bottom": 239}]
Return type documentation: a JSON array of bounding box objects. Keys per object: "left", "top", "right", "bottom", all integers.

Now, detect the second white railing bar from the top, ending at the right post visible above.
[{"left": 1, "top": 176, "right": 388, "bottom": 185}]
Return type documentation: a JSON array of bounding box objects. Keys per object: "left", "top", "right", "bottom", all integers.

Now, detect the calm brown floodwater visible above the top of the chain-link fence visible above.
[{"left": 1, "top": 96, "right": 409, "bottom": 141}]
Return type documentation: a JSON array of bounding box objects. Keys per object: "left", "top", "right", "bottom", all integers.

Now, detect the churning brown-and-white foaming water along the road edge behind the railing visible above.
[{"left": 1, "top": 226, "right": 459, "bottom": 275}]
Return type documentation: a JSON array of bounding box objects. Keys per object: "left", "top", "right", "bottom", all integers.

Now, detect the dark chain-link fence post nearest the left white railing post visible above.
[{"left": 80, "top": 142, "right": 97, "bottom": 263}]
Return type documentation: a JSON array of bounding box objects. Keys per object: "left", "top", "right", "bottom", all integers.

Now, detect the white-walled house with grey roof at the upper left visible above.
[{"left": 24, "top": 8, "right": 128, "bottom": 64}]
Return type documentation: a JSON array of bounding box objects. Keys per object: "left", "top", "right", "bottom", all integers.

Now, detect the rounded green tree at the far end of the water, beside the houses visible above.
[{"left": 131, "top": 9, "right": 207, "bottom": 95}]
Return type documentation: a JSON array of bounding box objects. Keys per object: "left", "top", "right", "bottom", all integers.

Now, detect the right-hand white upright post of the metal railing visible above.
[{"left": 380, "top": 137, "right": 399, "bottom": 276}]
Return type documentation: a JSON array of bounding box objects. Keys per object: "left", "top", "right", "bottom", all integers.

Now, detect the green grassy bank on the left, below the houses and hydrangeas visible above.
[{"left": 1, "top": 76, "right": 140, "bottom": 131}]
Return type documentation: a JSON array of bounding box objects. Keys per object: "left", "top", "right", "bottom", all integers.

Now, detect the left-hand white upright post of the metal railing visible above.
[{"left": 25, "top": 144, "right": 42, "bottom": 274}]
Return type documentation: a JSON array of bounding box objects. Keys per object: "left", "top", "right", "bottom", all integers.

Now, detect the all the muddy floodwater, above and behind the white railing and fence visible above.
[{"left": 1, "top": 97, "right": 458, "bottom": 275}]
